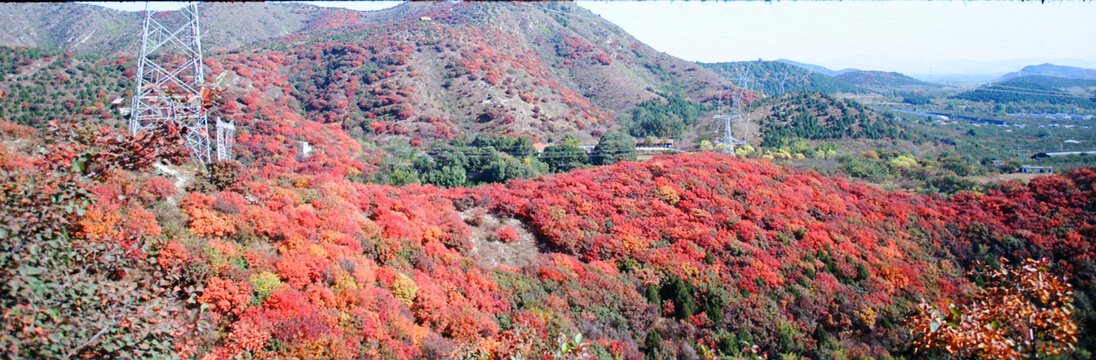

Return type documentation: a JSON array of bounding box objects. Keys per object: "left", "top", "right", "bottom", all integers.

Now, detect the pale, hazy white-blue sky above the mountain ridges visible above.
[{"left": 81, "top": 1, "right": 1096, "bottom": 78}]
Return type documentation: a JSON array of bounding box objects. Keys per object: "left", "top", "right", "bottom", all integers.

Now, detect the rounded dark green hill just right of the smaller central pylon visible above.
[{"left": 751, "top": 92, "right": 912, "bottom": 146}]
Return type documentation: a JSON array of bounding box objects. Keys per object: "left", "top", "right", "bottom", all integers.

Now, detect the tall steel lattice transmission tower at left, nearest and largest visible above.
[{"left": 129, "top": 2, "right": 213, "bottom": 166}]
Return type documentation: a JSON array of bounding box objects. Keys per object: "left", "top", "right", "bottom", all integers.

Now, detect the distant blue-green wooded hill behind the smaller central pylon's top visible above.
[{"left": 700, "top": 60, "right": 867, "bottom": 97}]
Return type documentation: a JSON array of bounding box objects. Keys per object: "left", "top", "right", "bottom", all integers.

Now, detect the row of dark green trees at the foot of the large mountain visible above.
[{"left": 366, "top": 133, "right": 637, "bottom": 188}]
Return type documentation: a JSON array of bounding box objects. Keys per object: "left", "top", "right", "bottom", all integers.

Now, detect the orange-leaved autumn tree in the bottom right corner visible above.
[{"left": 911, "top": 259, "right": 1077, "bottom": 359}]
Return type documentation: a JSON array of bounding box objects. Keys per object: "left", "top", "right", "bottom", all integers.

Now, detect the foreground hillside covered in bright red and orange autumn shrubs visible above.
[{"left": 0, "top": 119, "right": 1096, "bottom": 359}]
